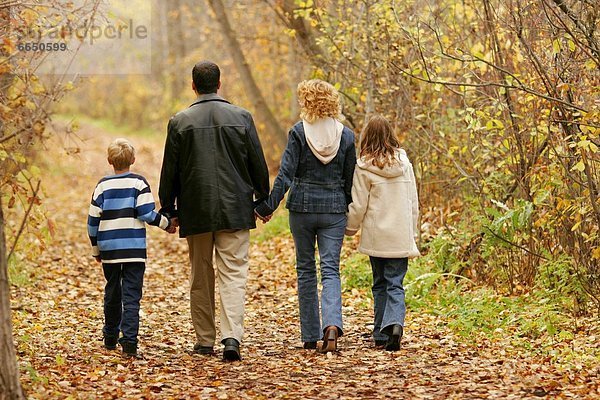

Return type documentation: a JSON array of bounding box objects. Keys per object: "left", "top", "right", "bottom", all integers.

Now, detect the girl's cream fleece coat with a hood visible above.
[{"left": 347, "top": 149, "right": 420, "bottom": 258}]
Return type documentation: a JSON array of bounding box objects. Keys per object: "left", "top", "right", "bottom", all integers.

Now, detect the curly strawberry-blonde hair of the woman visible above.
[{"left": 298, "top": 79, "right": 343, "bottom": 123}]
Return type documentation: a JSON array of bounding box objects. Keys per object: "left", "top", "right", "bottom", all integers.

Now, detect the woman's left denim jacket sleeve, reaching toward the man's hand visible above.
[{"left": 256, "top": 129, "right": 301, "bottom": 217}]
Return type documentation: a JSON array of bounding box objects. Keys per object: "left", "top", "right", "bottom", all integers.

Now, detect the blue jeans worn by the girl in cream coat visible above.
[{"left": 370, "top": 257, "right": 408, "bottom": 340}]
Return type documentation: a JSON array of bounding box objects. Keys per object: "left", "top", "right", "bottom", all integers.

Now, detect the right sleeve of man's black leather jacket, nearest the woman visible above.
[{"left": 246, "top": 114, "right": 269, "bottom": 202}]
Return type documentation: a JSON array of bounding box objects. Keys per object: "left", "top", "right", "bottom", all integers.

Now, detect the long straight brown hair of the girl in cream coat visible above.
[{"left": 360, "top": 115, "right": 400, "bottom": 169}]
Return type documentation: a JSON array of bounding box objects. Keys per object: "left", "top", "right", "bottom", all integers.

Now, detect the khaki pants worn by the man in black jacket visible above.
[{"left": 186, "top": 230, "right": 250, "bottom": 346}]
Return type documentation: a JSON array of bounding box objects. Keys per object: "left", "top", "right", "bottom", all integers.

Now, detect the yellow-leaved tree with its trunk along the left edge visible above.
[{"left": 0, "top": 1, "right": 99, "bottom": 399}]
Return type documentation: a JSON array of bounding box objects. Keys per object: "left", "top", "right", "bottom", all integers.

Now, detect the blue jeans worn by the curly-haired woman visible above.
[{"left": 290, "top": 212, "right": 346, "bottom": 342}]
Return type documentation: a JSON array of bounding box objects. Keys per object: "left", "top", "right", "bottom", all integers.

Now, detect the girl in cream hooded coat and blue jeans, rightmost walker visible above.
[{"left": 346, "top": 116, "right": 420, "bottom": 351}]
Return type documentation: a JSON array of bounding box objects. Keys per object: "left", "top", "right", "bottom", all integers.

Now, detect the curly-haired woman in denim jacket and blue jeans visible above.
[{"left": 255, "top": 79, "right": 356, "bottom": 353}]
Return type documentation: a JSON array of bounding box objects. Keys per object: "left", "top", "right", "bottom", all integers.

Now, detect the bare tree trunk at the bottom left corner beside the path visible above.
[{"left": 0, "top": 194, "right": 25, "bottom": 400}]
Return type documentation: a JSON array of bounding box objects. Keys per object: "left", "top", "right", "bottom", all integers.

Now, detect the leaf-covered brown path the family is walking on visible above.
[{"left": 13, "top": 126, "right": 600, "bottom": 399}]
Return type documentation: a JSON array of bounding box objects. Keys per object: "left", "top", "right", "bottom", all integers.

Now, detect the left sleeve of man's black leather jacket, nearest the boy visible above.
[{"left": 158, "top": 118, "right": 180, "bottom": 218}]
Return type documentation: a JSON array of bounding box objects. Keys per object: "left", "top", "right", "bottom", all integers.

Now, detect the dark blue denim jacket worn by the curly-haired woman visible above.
[{"left": 256, "top": 121, "right": 356, "bottom": 216}]
